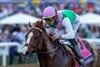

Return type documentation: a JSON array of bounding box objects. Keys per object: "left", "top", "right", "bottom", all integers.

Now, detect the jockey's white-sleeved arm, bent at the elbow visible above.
[{"left": 61, "top": 18, "right": 75, "bottom": 39}]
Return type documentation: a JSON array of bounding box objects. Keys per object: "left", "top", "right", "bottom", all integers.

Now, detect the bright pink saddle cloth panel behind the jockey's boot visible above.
[{"left": 77, "top": 38, "right": 94, "bottom": 64}]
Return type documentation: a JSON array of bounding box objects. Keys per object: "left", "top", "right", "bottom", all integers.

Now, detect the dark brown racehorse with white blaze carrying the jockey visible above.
[{"left": 22, "top": 21, "right": 97, "bottom": 67}]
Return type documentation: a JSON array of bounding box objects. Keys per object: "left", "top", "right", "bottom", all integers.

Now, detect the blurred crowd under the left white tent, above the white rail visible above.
[{"left": 0, "top": 24, "right": 27, "bottom": 43}]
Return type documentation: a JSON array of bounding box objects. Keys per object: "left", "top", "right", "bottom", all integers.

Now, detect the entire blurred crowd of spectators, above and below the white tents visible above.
[{"left": 0, "top": 0, "right": 100, "bottom": 64}]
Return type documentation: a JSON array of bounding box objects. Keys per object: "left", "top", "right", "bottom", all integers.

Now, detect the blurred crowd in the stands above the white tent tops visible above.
[{"left": 0, "top": 0, "right": 100, "bottom": 18}]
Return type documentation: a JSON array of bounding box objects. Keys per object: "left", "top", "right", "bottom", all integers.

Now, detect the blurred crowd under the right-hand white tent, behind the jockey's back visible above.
[{"left": 77, "top": 24, "right": 100, "bottom": 39}]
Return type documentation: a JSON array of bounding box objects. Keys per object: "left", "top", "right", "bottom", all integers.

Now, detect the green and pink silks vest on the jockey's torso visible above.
[{"left": 50, "top": 10, "right": 76, "bottom": 29}]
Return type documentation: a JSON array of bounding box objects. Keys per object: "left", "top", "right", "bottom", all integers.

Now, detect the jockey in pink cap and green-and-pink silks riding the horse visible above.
[{"left": 42, "top": 6, "right": 84, "bottom": 65}]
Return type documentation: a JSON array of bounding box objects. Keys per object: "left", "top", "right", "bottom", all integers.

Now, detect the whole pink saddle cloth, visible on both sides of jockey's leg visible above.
[{"left": 63, "top": 38, "right": 94, "bottom": 67}]
